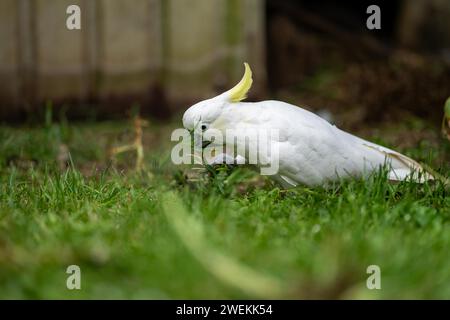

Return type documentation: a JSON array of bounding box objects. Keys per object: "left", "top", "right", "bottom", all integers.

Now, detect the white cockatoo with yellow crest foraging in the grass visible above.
[{"left": 183, "top": 63, "right": 433, "bottom": 188}]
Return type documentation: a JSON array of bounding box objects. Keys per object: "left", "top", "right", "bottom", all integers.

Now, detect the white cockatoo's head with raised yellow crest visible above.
[{"left": 183, "top": 63, "right": 253, "bottom": 131}]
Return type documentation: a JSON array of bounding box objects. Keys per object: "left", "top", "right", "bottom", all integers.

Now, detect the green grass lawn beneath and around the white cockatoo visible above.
[{"left": 0, "top": 118, "right": 450, "bottom": 299}]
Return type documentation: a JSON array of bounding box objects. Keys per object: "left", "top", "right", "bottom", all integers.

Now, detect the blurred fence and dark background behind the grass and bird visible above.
[{"left": 0, "top": 0, "right": 450, "bottom": 129}]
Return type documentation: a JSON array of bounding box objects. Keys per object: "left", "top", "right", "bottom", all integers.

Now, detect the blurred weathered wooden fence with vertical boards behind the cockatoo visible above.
[{"left": 0, "top": 0, "right": 265, "bottom": 118}]
